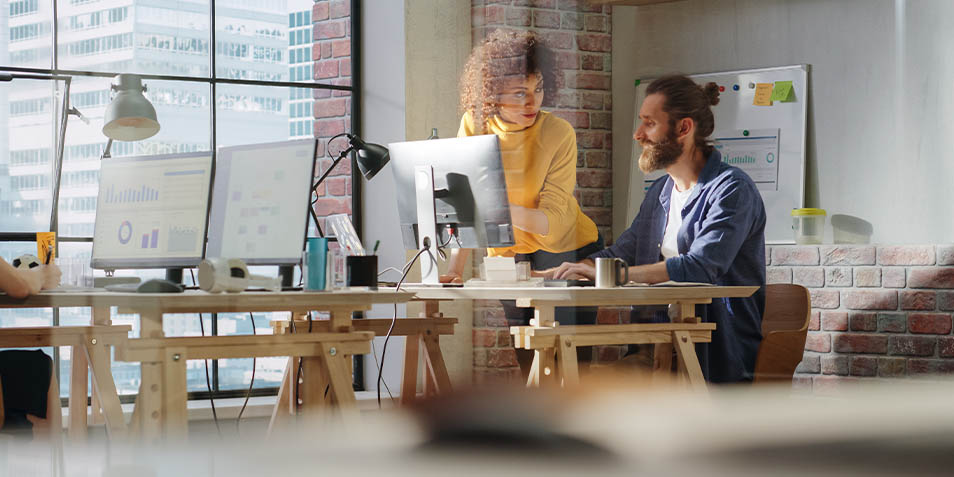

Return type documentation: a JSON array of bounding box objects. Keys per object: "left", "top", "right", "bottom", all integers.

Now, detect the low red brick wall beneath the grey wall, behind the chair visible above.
[{"left": 766, "top": 245, "right": 954, "bottom": 392}]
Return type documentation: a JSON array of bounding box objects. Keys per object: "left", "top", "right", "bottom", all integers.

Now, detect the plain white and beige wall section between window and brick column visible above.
[{"left": 361, "top": 0, "right": 473, "bottom": 393}]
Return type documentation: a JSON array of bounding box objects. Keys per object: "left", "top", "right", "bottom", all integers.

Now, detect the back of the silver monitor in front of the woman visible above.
[{"left": 388, "top": 134, "right": 514, "bottom": 249}]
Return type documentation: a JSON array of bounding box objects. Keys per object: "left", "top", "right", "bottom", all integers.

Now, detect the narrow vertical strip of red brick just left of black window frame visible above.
[{"left": 311, "top": 0, "right": 352, "bottom": 230}]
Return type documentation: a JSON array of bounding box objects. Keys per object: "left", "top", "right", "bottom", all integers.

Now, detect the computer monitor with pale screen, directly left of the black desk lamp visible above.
[{"left": 206, "top": 139, "right": 317, "bottom": 266}]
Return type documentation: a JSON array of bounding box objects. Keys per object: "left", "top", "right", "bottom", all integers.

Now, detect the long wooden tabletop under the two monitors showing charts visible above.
[{"left": 0, "top": 290, "right": 414, "bottom": 313}]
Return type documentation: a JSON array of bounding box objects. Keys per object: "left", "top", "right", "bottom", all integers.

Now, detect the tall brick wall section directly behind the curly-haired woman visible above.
[{"left": 471, "top": 0, "right": 616, "bottom": 381}]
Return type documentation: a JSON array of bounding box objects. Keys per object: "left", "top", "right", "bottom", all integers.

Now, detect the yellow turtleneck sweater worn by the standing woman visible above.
[{"left": 457, "top": 111, "right": 597, "bottom": 256}]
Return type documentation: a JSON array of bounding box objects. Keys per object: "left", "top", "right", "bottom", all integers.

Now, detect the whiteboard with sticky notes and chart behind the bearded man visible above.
[{"left": 626, "top": 65, "right": 809, "bottom": 244}]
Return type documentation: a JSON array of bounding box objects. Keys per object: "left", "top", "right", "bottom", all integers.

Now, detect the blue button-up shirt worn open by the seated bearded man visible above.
[{"left": 589, "top": 150, "right": 765, "bottom": 382}]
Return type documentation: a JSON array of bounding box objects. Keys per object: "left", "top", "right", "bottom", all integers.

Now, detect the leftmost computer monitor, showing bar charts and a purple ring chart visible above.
[{"left": 91, "top": 152, "right": 213, "bottom": 270}]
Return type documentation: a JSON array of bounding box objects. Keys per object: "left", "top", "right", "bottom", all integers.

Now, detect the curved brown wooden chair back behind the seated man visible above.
[{"left": 755, "top": 284, "right": 812, "bottom": 384}]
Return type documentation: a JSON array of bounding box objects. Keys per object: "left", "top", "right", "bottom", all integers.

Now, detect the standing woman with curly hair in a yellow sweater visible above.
[{"left": 442, "top": 30, "right": 603, "bottom": 364}]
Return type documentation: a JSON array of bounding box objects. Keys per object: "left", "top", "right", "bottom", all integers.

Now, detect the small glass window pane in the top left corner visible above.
[{"left": 0, "top": 0, "right": 53, "bottom": 68}]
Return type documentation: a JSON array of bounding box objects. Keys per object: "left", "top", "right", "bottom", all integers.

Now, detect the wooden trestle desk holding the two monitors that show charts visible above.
[{"left": 0, "top": 290, "right": 413, "bottom": 442}]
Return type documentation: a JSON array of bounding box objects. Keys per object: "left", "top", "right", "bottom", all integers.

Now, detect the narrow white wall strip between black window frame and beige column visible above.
[{"left": 359, "top": 0, "right": 406, "bottom": 390}]
